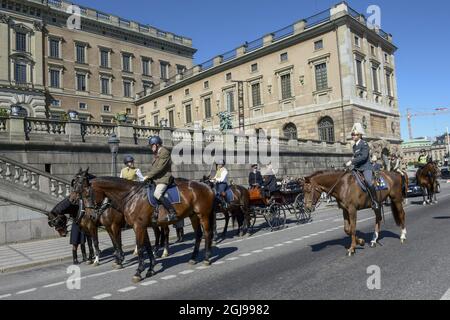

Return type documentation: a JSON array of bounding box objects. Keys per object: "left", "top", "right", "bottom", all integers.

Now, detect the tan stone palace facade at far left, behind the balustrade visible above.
[{"left": 0, "top": 0, "right": 196, "bottom": 122}]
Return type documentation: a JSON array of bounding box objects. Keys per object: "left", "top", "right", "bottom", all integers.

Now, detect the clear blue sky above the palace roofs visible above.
[{"left": 73, "top": 0, "right": 450, "bottom": 140}]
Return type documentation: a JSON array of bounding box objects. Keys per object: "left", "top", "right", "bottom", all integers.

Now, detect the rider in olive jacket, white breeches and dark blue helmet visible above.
[{"left": 145, "top": 136, "right": 177, "bottom": 221}]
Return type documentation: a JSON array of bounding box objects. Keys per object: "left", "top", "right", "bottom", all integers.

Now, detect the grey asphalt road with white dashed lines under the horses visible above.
[{"left": 0, "top": 185, "right": 450, "bottom": 300}]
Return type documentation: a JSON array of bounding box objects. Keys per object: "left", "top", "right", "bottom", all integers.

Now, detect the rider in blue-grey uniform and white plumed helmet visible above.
[{"left": 346, "top": 123, "right": 380, "bottom": 210}]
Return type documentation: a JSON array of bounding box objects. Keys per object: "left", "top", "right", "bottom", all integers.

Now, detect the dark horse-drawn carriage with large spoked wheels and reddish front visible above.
[{"left": 249, "top": 183, "right": 311, "bottom": 231}]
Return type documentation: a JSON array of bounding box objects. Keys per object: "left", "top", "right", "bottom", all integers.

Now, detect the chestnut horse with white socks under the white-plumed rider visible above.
[{"left": 303, "top": 171, "right": 406, "bottom": 256}]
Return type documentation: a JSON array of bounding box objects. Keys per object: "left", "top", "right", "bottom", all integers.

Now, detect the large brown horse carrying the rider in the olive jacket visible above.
[{"left": 74, "top": 171, "right": 214, "bottom": 282}]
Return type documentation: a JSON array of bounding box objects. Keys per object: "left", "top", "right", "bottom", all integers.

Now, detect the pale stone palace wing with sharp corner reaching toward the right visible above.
[{"left": 136, "top": 3, "right": 401, "bottom": 144}]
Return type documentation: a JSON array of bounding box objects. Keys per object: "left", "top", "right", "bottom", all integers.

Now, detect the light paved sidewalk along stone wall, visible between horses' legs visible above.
[{"left": 0, "top": 202, "right": 334, "bottom": 273}]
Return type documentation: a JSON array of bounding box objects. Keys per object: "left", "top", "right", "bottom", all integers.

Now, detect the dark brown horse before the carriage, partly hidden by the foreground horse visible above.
[{"left": 201, "top": 176, "right": 250, "bottom": 241}]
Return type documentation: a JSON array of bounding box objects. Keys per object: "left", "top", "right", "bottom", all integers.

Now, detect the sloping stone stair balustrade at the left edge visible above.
[{"left": 0, "top": 156, "right": 70, "bottom": 198}]
